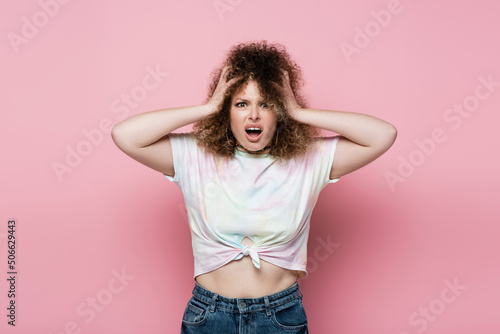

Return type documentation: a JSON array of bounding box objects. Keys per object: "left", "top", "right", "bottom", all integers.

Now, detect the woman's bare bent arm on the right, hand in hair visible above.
[{"left": 284, "top": 72, "right": 397, "bottom": 179}]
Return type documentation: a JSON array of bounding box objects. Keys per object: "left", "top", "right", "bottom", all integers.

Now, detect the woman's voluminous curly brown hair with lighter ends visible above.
[{"left": 193, "top": 40, "right": 319, "bottom": 160}]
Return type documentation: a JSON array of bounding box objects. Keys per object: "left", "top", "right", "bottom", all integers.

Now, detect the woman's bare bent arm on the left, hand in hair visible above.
[{"left": 111, "top": 69, "right": 238, "bottom": 176}]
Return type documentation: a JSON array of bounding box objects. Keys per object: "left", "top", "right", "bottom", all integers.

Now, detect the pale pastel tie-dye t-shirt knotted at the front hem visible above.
[{"left": 164, "top": 133, "right": 340, "bottom": 279}]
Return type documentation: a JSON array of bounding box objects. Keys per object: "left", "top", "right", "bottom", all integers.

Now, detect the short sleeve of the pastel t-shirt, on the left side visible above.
[{"left": 163, "top": 133, "right": 196, "bottom": 185}]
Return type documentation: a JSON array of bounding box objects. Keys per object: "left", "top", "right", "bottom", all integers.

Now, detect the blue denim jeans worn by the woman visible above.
[{"left": 181, "top": 281, "right": 309, "bottom": 334}]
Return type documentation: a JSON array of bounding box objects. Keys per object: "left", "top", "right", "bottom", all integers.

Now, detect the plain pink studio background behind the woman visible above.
[{"left": 0, "top": 0, "right": 500, "bottom": 334}]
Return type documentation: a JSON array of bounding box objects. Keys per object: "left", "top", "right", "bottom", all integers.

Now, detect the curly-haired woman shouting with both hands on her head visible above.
[{"left": 112, "top": 41, "right": 396, "bottom": 334}]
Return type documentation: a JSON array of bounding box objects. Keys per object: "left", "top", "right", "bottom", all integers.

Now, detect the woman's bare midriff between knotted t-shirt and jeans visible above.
[{"left": 196, "top": 237, "right": 299, "bottom": 298}]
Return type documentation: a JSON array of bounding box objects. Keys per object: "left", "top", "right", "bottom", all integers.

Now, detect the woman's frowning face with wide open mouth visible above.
[{"left": 230, "top": 80, "right": 277, "bottom": 153}]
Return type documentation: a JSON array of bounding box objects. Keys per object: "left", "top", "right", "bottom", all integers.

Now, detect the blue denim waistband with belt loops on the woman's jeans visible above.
[{"left": 193, "top": 281, "right": 302, "bottom": 314}]
